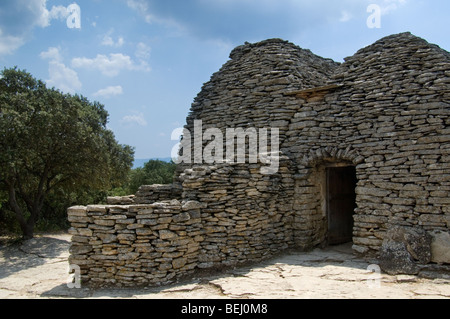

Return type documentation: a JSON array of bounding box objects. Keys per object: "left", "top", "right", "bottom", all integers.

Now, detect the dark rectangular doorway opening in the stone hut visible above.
[{"left": 326, "top": 166, "right": 356, "bottom": 245}]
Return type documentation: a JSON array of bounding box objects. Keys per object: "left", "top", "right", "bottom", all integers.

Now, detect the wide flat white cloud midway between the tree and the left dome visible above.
[{"left": 72, "top": 53, "right": 150, "bottom": 77}]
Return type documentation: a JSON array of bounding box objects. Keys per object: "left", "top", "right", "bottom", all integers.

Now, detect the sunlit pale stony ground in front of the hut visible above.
[{"left": 0, "top": 234, "right": 450, "bottom": 299}]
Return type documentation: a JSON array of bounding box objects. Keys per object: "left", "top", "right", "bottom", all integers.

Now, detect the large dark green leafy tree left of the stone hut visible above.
[{"left": 0, "top": 68, "right": 134, "bottom": 237}]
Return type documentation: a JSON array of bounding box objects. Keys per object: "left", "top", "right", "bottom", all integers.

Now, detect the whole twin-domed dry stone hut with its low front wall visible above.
[{"left": 68, "top": 33, "right": 450, "bottom": 285}]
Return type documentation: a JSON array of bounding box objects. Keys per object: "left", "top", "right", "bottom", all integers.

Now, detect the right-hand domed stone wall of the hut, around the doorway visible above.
[{"left": 282, "top": 34, "right": 450, "bottom": 253}]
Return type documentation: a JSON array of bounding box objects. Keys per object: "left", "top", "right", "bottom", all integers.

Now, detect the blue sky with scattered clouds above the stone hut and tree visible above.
[{"left": 0, "top": 0, "right": 450, "bottom": 158}]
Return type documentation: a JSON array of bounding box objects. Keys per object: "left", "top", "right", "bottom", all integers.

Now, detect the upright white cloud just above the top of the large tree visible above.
[{"left": 40, "top": 47, "right": 82, "bottom": 94}]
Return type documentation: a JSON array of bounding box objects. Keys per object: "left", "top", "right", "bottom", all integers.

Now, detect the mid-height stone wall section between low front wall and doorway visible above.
[{"left": 180, "top": 161, "right": 294, "bottom": 267}]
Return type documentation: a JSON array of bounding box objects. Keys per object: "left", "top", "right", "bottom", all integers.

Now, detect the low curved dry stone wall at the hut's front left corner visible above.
[{"left": 68, "top": 200, "right": 204, "bottom": 286}]
